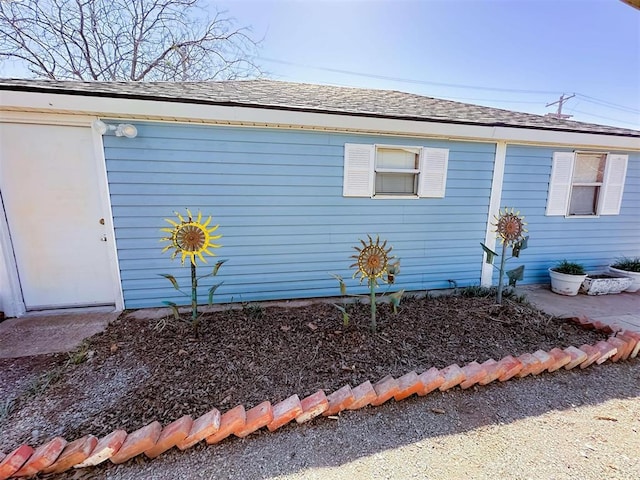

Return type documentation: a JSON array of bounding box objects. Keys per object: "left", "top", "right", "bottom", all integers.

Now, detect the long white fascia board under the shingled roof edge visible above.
[{"left": 0, "top": 90, "right": 640, "bottom": 150}]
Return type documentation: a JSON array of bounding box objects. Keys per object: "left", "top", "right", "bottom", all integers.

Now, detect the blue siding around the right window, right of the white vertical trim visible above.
[{"left": 496, "top": 146, "right": 640, "bottom": 283}]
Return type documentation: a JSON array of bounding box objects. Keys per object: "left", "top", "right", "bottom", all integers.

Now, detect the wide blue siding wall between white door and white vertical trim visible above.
[{"left": 104, "top": 123, "right": 495, "bottom": 308}]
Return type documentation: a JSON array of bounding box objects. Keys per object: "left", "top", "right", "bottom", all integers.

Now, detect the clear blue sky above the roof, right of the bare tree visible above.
[{"left": 209, "top": 0, "right": 640, "bottom": 129}]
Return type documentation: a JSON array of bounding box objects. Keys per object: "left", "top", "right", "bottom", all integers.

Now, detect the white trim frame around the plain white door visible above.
[{"left": 0, "top": 111, "right": 124, "bottom": 317}]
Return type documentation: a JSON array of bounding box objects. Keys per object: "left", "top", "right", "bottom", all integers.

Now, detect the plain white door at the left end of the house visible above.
[{"left": 0, "top": 123, "right": 115, "bottom": 310}]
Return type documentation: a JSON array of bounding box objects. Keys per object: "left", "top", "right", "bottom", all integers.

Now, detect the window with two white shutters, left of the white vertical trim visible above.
[{"left": 343, "top": 143, "right": 449, "bottom": 198}]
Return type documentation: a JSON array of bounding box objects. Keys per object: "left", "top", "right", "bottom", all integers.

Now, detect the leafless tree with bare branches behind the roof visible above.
[{"left": 0, "top": 0, "right": 260, "bottom": 81}]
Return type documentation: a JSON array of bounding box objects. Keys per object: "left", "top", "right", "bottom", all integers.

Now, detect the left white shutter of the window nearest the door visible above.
[{"left": 342, "top": 143, "right": 376, "bottom": 197}]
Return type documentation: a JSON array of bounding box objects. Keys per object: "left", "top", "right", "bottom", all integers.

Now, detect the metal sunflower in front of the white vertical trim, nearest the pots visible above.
[{"left": 480, "top": 207, "right": 529, "bottom": 304}]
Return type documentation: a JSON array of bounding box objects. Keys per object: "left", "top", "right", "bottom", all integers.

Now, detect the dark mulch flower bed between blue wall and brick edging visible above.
[{"left": 0, "top": 295, "right": 606, "bottom": 448}]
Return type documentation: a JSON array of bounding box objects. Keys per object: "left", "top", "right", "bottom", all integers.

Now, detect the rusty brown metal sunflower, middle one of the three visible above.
[{"left": 348, "top": 235, "right": 402, "bottom": 333}]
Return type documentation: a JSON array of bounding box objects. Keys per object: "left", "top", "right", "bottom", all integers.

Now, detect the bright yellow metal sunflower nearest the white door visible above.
[{"left": 160, "top": 209, "right": 226, "bottom": 335}]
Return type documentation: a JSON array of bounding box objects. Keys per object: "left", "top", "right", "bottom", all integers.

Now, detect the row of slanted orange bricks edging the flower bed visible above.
[{"left": 0, "top": 316, "right": 640, "bottom": 480}]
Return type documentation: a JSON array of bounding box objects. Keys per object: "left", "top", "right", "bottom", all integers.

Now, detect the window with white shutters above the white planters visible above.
[{"left": 547, "top": 152, "right": 628, "bottom": 217}]
